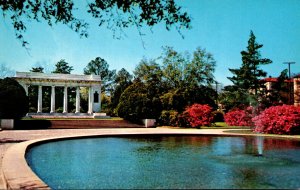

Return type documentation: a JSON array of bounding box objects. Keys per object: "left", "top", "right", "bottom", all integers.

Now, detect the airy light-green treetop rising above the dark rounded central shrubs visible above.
[{"left": 162, "top": 47, "right": 216, "bottom": 88}]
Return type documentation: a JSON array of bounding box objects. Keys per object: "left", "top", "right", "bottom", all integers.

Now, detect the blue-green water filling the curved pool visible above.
[{"left": 26, "top": 136, "right": 300, "bottom": 189}]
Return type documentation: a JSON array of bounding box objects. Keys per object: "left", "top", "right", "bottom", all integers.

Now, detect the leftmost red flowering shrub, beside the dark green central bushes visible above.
[{"left": 179, "top": 104, "right": 213, "bottom": 127}]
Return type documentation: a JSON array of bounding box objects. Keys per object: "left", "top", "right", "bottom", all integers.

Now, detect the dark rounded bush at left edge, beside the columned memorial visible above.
[{"left": 0, "top": 78, "right": 29, "bottom": 119}]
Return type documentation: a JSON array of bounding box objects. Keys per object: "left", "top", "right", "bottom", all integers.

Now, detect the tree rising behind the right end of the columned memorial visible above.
[{"left": 83, "top": 57, "right": 116, "bottom": 91}]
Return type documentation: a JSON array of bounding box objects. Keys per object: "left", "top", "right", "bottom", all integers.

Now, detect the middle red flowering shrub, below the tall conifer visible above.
[{"left": 224, "top": 106, "right": 254, "bottom": 126}]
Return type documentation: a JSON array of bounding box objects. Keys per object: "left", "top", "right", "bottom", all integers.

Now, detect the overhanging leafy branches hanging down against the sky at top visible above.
[{"left": 0, "top": 0, "right": 191, "bottom": 47}]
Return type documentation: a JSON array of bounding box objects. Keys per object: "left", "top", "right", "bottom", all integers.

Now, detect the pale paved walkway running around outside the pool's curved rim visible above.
[{"left": 0, "top": 127, "right": 300, "bottom": 189}]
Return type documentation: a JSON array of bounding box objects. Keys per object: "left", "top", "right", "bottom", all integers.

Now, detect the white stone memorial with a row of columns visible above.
[{"left": 14, "top": 72, "right": 101, "bottom": 116}]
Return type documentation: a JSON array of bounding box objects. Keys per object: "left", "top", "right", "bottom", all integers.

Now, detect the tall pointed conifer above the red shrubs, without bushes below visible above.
[{"left": 228, "top": 31, "right": 272, "bottom": 95}]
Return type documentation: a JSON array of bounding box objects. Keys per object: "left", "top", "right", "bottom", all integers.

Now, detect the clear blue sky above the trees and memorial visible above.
[{"left": 0, "top": 0, "right": 300, "bottom": 85}]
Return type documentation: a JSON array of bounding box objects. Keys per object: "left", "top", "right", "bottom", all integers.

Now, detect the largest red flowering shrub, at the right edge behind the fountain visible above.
[{"left": 252, "top": 105, "right": 300, "bottom": 134}]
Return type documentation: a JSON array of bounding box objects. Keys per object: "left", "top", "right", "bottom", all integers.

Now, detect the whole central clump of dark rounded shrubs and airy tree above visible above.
[{"left": 112, "top": 47, "right": 217, "bottom": 125}]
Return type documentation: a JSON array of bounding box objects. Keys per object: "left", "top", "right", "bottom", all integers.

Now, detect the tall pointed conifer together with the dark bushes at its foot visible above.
[{"left": 226, "top": 31, "right": 272, "bottom": 111}]
